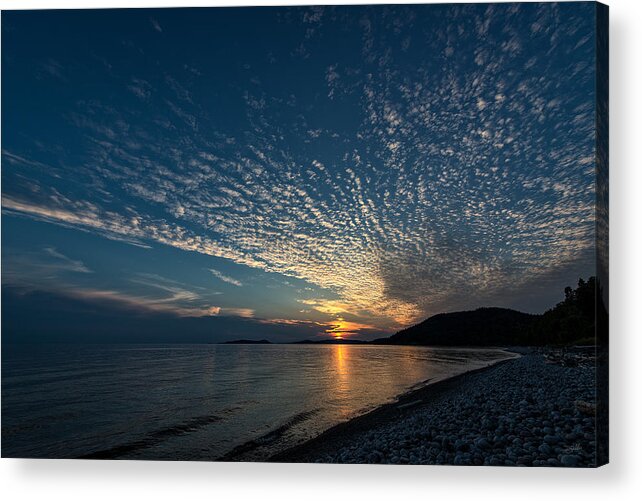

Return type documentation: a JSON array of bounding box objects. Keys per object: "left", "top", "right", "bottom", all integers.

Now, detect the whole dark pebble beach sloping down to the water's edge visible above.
[{"left": 264, "top": 348, "right": 597, "bottom": 467}]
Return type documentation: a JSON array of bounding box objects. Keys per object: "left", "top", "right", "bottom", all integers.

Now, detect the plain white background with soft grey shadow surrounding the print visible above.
[{"left": 0, "top": 0, "right": 642, "bottom": 501}]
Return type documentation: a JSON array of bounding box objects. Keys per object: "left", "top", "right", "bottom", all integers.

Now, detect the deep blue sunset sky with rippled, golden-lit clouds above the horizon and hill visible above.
[{"left": 2, "top": 2, "right": 595, "bottom": 342}]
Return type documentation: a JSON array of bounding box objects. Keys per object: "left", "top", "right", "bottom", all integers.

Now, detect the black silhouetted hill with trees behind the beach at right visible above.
[{"left": 374, "top": 277, "right": 605, "bottom": 346}]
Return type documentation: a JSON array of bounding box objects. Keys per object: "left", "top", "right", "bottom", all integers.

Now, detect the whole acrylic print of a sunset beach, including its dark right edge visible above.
[{"left": 2, "top": 2, "right": 608, "bottom": 467}]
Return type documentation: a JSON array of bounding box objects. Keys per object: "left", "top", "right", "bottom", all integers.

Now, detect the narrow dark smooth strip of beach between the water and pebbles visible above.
[{"left": 263, "top": 354, "right": 521, "bottom": 463}]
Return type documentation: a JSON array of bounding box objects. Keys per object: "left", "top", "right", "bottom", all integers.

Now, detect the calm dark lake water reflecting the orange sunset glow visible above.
[{"left": 2, "top": 345, "right": 511, "bottom": 460}]
